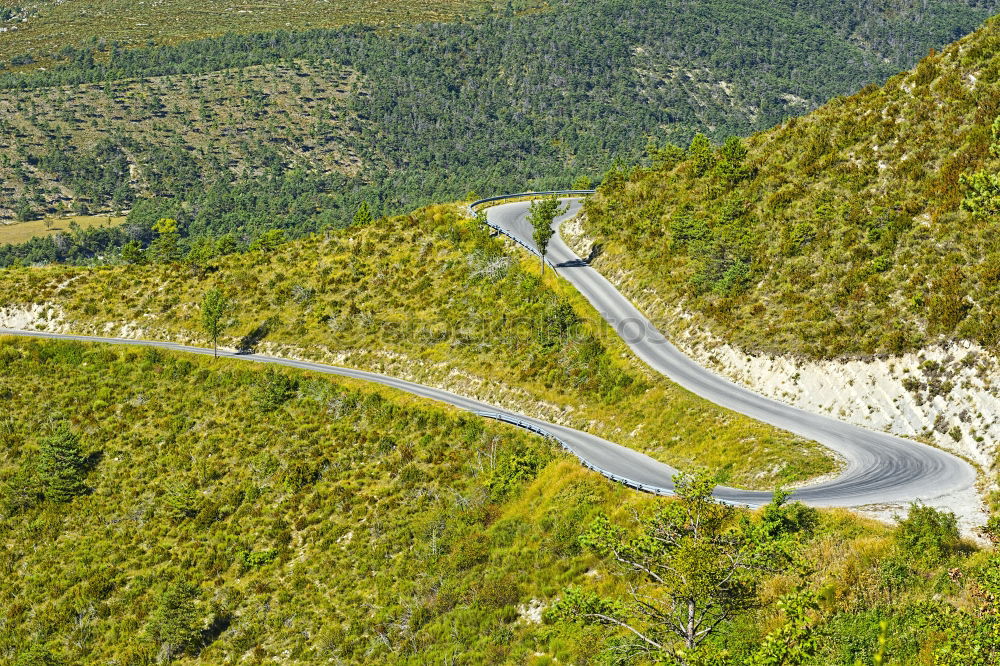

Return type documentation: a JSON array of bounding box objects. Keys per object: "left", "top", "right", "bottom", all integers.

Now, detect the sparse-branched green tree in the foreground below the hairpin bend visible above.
[{"left": 549, "top": 475, "right": 808, "bottom": 664}]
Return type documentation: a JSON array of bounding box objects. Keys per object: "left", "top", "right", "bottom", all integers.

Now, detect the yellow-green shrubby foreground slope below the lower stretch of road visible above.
[{"left": 0, "top": 338, "right": 985, "bottom": 664}]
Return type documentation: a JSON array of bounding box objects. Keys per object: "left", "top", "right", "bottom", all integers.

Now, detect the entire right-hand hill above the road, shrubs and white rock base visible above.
[{"left": 567, "top": 16, "right": 1000, "bottom": 472}]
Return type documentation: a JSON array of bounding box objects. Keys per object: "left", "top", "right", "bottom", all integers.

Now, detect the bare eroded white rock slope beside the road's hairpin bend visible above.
[{"left": 678, "top": 331, "right": 1000, "bottom": 470}]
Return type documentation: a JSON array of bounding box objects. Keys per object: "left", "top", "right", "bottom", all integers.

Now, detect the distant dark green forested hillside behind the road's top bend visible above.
[{"left": 0, "top": 0, "right": 994, "bottom": 265}]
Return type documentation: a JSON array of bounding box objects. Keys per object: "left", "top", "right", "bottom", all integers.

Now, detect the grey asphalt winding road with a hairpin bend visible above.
[{"left": 0, "top": 198, "right": 976, "bottom": 507}]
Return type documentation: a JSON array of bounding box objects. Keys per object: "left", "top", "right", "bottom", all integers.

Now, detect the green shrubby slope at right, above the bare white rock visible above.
[{"left": 585, "top": 20, "right": 1000, "bottom": 358}]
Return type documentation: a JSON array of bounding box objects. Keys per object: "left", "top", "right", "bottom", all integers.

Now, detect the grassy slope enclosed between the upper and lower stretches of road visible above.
[{"left": 0, "top": 206, "right": 834, "bottom": 488}]
